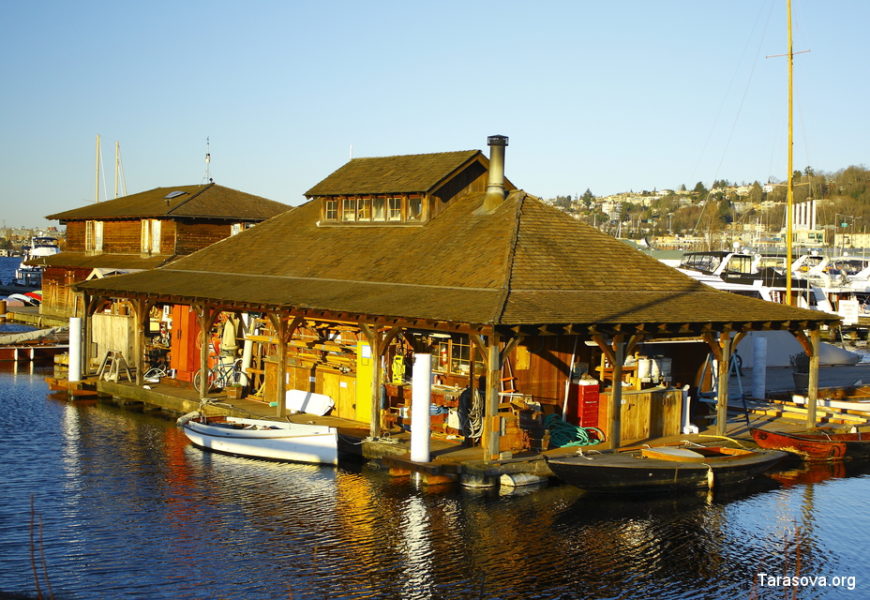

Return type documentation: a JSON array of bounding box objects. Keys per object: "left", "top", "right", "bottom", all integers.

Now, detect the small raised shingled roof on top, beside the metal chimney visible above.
[{"left": 305, "top": 150, "right": 487, "bottom": 197}]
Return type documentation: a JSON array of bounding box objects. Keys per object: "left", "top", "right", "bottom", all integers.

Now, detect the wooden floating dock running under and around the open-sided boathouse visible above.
[{"left": 51, "top": 365, "right": 870, "bottom": 488}]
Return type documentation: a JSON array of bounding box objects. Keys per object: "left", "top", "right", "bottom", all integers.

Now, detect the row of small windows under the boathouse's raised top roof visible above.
[{"left": 321, "top": 196, "right": 427, "bottom": 225}]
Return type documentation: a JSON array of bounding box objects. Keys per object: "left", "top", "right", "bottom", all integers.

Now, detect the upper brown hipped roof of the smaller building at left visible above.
[{"left": 45, "top": 183, "right": 290, "bottom": 222}]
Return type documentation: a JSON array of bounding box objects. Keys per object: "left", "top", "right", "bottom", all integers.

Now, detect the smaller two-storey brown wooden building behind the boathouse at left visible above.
[{"left": 34, "top": 183, "right": 290, "bottom": 317}]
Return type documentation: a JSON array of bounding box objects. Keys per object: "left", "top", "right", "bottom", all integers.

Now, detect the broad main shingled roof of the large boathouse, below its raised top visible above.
[{"left": 78, "top": 186, "right": 837, "bottom": 326}]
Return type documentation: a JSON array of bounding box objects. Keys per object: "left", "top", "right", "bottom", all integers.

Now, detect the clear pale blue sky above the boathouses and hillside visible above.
[{"left": 0, "top": 0, "right": 870, "bottom": 226}]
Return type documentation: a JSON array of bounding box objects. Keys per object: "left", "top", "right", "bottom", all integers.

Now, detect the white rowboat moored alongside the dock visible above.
[{"left": 179, "top": 417, "right": 338, "bottom": 465}]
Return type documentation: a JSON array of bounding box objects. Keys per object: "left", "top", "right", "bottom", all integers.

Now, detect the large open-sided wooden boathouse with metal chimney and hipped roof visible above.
[{"left": 75, "top": 136, "right": 838, "bottom": 459}]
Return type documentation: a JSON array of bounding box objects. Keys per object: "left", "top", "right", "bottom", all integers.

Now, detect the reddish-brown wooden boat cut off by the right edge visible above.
[{"left": 751, "top": 428, "right": 870, "bottom": 462}]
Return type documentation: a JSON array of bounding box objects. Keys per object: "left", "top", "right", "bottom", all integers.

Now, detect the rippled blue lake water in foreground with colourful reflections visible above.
[{"left": 0, "top": 366, "right": 870, "bottom": 600}]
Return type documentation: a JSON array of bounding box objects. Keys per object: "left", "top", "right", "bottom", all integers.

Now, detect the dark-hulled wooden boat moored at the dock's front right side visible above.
[{"left": 545, "top": 446, "right": 787, "bottom": 493}]
